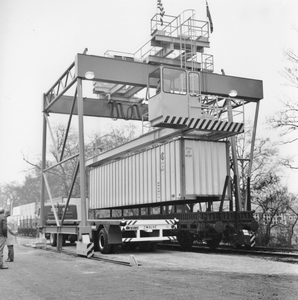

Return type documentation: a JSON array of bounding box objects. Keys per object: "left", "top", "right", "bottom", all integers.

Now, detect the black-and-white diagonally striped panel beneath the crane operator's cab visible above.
[{"left": 163, "top": 116, "right": 244, "bottom": 133}]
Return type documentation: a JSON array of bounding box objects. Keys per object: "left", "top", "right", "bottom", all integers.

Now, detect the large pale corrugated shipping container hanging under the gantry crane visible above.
[{"left": 90, "top": 139, "right": 227, "bottom": 208}]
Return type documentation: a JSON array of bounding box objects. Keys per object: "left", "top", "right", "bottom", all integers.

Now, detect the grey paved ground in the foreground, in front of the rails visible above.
[{"left": 0, "top": 241, "right": 298, "bottom": 300}]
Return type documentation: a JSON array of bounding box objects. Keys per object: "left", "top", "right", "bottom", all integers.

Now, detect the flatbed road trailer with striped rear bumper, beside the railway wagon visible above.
[{"left": 44, "top": 218, "right": 178, "bottom": 254}]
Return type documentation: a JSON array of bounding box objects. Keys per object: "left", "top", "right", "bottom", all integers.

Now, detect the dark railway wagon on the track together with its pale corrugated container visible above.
[{"left": 89, "top": 134, "right": 258, "bottom": 248}]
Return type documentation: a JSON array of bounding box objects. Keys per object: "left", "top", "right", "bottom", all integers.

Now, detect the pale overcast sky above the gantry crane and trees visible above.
[{"left": 0, "top": 0, "right": 298, "bottom": 192}]
